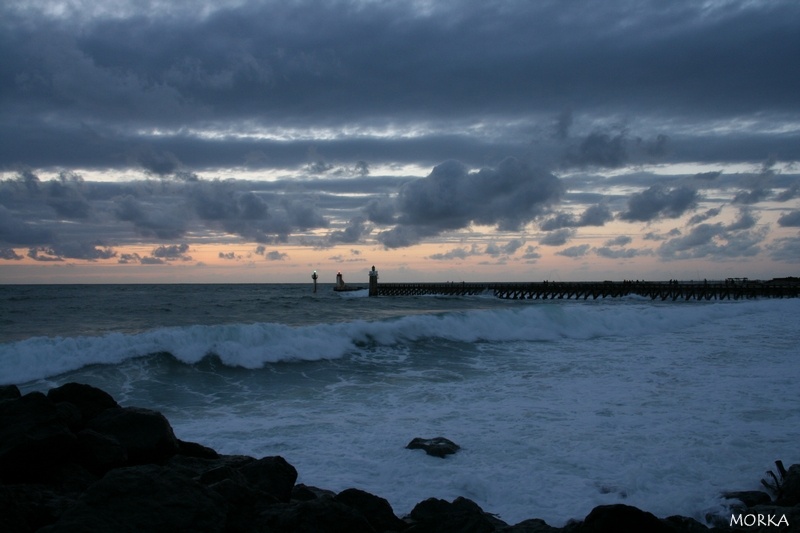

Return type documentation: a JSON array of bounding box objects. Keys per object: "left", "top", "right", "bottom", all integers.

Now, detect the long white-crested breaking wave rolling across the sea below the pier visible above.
[{"left": 0, "top": 302, "right": 796, "bottom": 384}]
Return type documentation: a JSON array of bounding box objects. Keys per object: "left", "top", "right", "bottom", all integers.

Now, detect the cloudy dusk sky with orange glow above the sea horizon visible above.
[{"left": 0, "top": 0, "right": 800, "bottom": 283}]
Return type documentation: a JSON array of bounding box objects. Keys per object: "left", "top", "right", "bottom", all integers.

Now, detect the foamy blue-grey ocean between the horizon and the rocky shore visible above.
[{"left": 0, "top": 283, "right": 800, "bottom": 526}]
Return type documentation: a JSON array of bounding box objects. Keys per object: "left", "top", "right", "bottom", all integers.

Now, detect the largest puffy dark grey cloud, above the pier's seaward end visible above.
[{"left": 378, "top": 158, "right": 563, "bottom": 248}]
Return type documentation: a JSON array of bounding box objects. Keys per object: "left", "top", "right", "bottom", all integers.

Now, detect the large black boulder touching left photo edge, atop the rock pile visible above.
[{"left": 0, "top": 392, "right": 78, "bottom": 482}]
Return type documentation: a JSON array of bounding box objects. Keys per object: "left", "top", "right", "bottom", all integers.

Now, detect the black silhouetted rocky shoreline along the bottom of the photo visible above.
[{"left": 0, "top": 383, "right": 800, "bottom": 533}]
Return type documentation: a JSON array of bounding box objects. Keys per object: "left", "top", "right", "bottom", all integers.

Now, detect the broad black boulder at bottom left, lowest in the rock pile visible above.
[{"left": 41, "top": 465, "right": 227, "bottom": 533}]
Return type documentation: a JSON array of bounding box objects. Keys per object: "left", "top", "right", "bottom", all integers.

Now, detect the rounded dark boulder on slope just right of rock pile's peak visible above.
[{"left": 87, "top": 407, "right": 178, "bottom": 464}]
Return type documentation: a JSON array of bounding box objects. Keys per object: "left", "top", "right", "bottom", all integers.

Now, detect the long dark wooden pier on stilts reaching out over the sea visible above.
[{"left": 370, "top": 278, "right": 800, "bottom": 301}]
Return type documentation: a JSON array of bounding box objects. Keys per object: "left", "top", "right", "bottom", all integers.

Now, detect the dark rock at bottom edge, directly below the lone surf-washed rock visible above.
[{"left": 406, "top": 498, "right": 508, "bottom": 533}]
